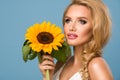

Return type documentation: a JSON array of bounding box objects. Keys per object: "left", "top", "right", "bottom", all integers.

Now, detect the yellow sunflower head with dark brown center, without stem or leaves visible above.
[{"left": 25, "top": 21, "right": 64, "bottom": 54}]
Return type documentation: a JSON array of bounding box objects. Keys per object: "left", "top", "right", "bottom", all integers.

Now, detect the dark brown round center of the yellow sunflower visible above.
[{"left": 37, "top": 32, "right": 54, "bottom": 44}]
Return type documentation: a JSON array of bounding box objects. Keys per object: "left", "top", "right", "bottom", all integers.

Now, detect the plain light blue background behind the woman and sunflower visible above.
[{"left": 0, "top": 0, "right": 120, "bottom": 80}]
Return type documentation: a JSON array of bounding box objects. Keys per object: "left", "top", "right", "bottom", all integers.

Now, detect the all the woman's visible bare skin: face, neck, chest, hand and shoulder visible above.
[{"left": 39, "top": 5, "right": 113, "bottom": 80}]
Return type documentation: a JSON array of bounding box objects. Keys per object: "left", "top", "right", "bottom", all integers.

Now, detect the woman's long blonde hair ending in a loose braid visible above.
[{"left": 63, "top": 0, "right": 111, "bottom": 80}]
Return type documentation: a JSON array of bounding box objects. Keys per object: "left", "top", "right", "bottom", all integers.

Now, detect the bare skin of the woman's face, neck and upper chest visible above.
[{"left": 60, "top": 5, "right": 92, "bottom": 80}]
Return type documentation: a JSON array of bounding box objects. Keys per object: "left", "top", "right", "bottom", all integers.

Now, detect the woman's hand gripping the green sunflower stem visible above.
[{"left": 39, "top": 55, "right": 55, "bottom": 80}]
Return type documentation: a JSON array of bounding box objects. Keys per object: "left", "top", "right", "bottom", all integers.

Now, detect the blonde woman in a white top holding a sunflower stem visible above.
[{"left": 39, "top": 0, "right": 113, "bottom": 80}]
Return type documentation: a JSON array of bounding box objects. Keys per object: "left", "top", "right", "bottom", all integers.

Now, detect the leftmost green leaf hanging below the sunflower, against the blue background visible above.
[{"left": 22, "top": 45, "right": 30, "bottom": 62}]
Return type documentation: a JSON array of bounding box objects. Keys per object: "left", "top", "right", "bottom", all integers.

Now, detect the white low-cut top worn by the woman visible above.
[{"left": 53, "top": 65, "right": 82, "bottom": 80}]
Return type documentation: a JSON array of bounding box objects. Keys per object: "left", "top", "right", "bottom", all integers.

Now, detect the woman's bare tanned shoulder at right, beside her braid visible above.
[{"left": 88, "top": 57, "right": 113, "bottom": 80}]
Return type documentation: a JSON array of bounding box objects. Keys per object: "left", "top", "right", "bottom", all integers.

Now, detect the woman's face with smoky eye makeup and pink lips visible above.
[{"left": 64, "top": 5, "right": 92, "bottom": 46}]
